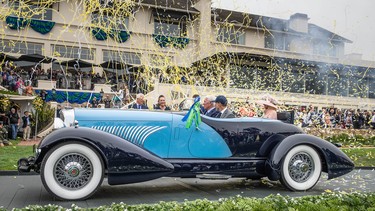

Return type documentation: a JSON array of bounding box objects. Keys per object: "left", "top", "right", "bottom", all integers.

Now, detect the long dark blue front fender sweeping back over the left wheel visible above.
[{"left": 35, "top": 127, "right": 174, "bottom": 185}]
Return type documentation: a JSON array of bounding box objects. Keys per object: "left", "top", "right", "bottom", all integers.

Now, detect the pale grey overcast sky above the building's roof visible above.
[{"left": 213, "top": 0, "right": 375, "bottom": 61}]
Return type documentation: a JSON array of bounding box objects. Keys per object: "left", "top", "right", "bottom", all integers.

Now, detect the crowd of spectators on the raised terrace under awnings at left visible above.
[{"left": 0, "top": 62, "right": 147, "bottom": 95}]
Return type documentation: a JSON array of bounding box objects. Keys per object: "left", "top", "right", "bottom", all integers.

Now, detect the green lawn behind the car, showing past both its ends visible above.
[{"left": 0, "top": 144, "right": 375, "bottom": 171}]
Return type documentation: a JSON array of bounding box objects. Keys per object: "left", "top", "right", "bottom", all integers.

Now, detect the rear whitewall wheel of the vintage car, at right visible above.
[{"left": 280, "top": 145, "right": 322, "bottom": 191}]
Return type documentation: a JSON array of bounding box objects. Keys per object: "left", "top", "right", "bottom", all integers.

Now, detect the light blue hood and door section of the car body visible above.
[{"left": 75, "top": 110, "right": 236, "bottom": 158}]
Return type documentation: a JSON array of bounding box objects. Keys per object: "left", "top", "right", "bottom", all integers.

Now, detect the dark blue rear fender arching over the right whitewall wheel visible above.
[{"left": 265, "top": 134, "right": 354, "bottom": 180}]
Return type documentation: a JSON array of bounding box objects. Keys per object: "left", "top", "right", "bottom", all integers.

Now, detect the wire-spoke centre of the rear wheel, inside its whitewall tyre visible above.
[{"left": 288, "top": 152, "right": 315, "bottom": 183}]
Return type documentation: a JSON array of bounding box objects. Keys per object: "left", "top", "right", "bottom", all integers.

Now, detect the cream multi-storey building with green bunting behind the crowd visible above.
[{"left": 0, "top": 0, "right": 375, "bottom": 109}]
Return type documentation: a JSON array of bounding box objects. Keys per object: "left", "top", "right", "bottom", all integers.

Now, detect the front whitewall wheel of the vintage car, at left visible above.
[{"left": 41, "top": 142, "right": 104, "bottom": 200}]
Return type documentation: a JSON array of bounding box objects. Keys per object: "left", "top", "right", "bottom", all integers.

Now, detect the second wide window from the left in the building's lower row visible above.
[{"left": 52, "top": 45, "right": 95, "bottom": 60}]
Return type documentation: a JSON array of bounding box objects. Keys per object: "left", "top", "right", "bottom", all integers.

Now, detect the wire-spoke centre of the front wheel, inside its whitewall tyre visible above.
[{"left": 54, "top": 153, "right": 93, "bottom": 189}]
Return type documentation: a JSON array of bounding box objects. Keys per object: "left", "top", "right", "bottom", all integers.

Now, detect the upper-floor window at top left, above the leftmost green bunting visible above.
[{"left": 10, "top": 1, "right": 52, "bottom": 20}]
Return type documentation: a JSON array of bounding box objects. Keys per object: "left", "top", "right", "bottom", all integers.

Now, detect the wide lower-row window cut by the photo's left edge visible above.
[{"left": 0, "top": 40, "right": 43, "bottom": 55}]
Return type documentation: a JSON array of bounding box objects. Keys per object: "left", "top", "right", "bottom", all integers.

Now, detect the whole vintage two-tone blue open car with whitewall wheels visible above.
[{"left": 18, "top": 109, "right": 354, "bottom": 200}]
